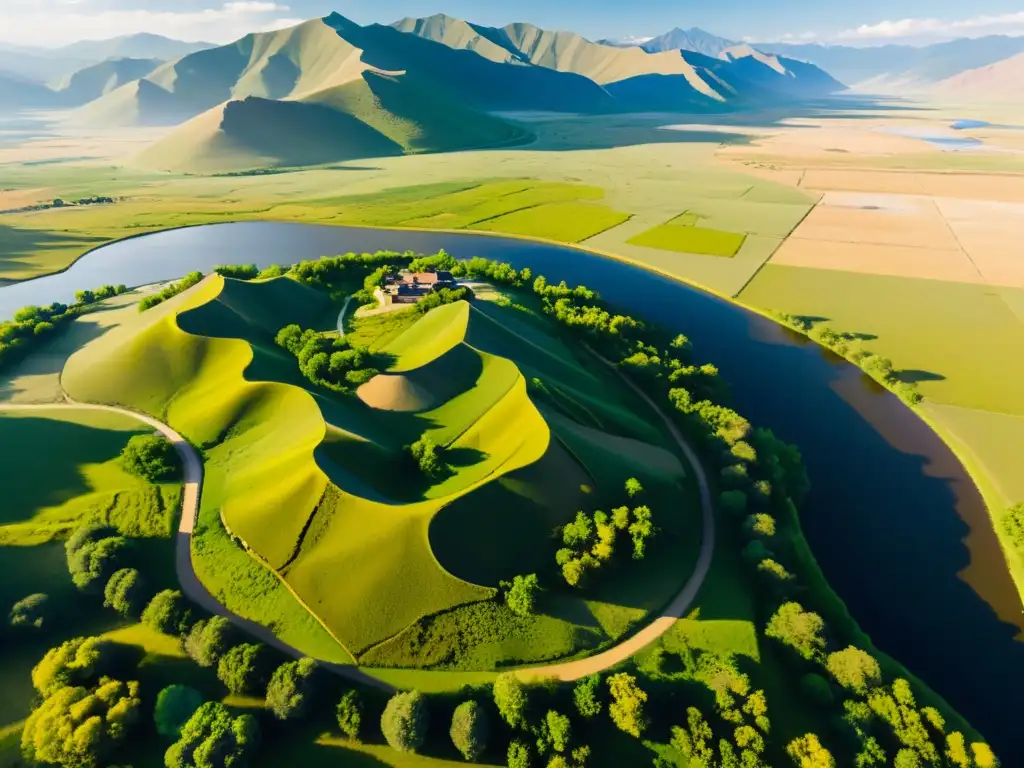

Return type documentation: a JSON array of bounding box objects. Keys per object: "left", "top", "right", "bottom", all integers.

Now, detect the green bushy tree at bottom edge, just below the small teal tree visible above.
[{"left": 164, "top": 701, "right": 259, "bottom": 768}]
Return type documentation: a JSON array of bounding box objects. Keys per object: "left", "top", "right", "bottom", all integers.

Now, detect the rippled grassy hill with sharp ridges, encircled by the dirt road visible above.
[{"left": 63, "top": 275, "right": 695, "bottom": 668}]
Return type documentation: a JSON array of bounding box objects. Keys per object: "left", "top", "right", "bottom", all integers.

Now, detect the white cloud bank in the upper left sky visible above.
[{"left": 0, "top": 0, "right": 305, "bottom": 47}]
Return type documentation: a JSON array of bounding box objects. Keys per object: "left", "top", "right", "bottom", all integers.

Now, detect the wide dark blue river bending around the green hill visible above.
[{"left": 0, "top": 222, "right": 1024, "bottom": 766}]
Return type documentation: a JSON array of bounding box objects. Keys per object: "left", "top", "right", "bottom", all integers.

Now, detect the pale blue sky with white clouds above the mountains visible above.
[{"left": 6, "top": 0, "right": 1024, "bottom": 45}]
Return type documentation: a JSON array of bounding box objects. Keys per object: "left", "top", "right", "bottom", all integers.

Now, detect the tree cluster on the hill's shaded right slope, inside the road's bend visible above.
[{"left": 555, "top": 477, "right": 656, "bottom": 587}]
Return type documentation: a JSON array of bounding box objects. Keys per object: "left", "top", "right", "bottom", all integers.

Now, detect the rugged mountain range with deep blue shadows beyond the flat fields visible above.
[{"left": 20, "top": 13, "right": 843, "bottom": 172}]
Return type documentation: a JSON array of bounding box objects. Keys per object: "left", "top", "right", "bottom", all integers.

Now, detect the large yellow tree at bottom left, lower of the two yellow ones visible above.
[{"left": 22, "top": 678, "right": 141, "bottom": 768}]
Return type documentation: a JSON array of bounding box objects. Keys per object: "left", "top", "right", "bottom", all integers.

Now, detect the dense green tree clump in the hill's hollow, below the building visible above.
[{"left": 274, "top": 325, "right": 380, "bottom": 393}]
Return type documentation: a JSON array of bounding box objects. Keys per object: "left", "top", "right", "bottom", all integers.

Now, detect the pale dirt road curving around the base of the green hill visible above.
[{"left": 0, "top": 346, "right": 715, "bottom": 691}]
